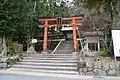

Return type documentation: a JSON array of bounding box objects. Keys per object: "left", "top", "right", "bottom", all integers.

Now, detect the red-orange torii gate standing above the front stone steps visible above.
[{"left": 38, "top": 17, "right": 83, "bottom": 52}]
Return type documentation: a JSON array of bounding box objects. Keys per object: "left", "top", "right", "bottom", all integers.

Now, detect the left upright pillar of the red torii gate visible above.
[{"left": 43, "top": 20, "right": 48, "bottom": 52}]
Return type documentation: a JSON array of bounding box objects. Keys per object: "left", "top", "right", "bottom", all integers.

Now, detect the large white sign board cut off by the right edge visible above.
[{"left": 112, "top": 30, "right": 120, "bottom": 57}]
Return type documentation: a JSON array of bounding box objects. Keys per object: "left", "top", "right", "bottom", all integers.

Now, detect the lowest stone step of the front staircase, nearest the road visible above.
[{"left": 9, "top": 68, "right": 78, "bottom": 75}]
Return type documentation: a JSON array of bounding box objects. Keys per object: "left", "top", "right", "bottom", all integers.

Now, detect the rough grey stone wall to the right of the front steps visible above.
[{"left": 78, "top": 57, "right": 120, "bottom": 76}]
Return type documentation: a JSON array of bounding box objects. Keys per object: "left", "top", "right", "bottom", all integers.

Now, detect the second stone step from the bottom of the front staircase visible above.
[{"left": 12, "top": 64, "right": 77, "bottom": 71}]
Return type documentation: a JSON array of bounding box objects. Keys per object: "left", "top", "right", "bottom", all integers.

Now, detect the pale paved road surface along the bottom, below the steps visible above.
[{"left": 0, "top": 74, "right": 120, "bottom": 80}]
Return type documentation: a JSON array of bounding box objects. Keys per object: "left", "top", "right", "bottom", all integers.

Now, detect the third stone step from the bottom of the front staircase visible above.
[{"left": 17, "top": 62, "right": 77, "bottom": 67}]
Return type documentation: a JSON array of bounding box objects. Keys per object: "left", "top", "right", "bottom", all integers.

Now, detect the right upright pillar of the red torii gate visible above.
[{"left": 72, "top": 17, "right": 77, "bottom": 52}]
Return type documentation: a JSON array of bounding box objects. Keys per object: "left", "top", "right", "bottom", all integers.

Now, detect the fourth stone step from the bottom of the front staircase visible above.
[{"left": 21, "top": 59, "right": 77, "bottom": 63}]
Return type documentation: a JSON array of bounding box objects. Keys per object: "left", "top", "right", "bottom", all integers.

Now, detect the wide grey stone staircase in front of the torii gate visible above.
[{"left": 7, "top": 54, "right": 78, "bottom": 75}]
